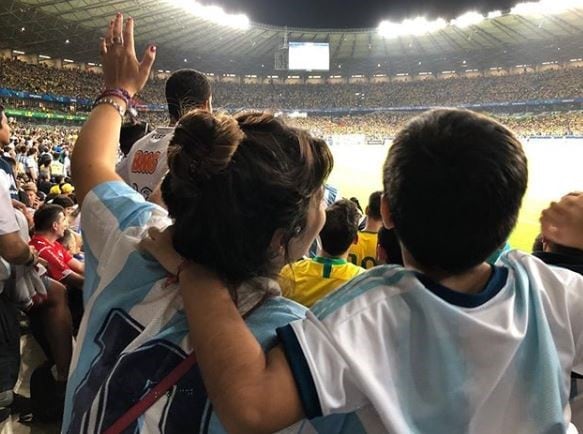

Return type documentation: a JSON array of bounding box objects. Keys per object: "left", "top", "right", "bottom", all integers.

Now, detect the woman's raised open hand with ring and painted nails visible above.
[{"left": 100, "top": 13, "right": 156, "bottom": 96}]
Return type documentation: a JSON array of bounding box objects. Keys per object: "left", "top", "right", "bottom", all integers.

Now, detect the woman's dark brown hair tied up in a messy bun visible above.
[{"left": 162, "top": 110, "right": 333, "bottom": 287}]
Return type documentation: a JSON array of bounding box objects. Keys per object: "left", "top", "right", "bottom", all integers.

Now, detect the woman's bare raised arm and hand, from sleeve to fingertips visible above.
[{"left": 71, "top": 13, "right": 156, "bottom": 204}]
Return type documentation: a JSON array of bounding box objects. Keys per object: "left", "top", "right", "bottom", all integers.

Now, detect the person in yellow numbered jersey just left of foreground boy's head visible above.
[{"left": 348, "top": 191, "right": 383, "bottom": 270}]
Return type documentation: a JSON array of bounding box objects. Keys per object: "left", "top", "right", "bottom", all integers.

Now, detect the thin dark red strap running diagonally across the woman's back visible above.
[{"left": 103, "top": 353, "right": 196, "bottom": 434}]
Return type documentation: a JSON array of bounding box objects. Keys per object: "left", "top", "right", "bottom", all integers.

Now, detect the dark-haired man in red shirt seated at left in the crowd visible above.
[{"left": 30, "top": 205, "right": 85, "bottom": 289}]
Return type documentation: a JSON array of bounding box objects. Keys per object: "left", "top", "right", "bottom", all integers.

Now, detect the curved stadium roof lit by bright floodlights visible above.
[{"left": 0, "top": 0, "right": 583, "bottom": 74}]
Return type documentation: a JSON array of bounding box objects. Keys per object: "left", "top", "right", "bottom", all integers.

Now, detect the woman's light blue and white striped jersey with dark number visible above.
[{"left": 62, "top": 182, "right": 358, "bottom": 434}]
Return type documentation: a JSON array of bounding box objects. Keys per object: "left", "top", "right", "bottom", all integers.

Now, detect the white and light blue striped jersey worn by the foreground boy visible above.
[{"left": 278, "top": 251, "right": 583, "bottom": 434}]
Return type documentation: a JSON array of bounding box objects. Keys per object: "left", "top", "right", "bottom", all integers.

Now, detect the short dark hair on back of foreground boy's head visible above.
[{"left": 383, "top": 109, "right": 528, "bottom": 274}]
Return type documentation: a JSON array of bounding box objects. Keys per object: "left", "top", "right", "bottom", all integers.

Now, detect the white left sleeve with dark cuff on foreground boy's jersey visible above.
[{"left": 278, "top": 312, "right": 368, "bottom": 419}]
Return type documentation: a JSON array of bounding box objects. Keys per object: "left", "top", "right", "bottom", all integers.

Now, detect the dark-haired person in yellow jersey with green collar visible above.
[{"left": 280, "top": 199, "right": 364, "bottom": 307}]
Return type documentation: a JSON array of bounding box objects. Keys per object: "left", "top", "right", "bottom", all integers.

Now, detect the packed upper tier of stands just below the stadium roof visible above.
[{"left": 0, "top": 60, "right": 583, "bottom": 110}]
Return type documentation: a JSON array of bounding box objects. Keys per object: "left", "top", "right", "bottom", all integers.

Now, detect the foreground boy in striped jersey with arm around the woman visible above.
[{"left": 148, "top": 109, "right": 583, "bottom": 433}]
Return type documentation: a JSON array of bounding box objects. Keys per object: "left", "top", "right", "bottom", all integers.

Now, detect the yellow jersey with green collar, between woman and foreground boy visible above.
[{"left": 280, "top": 256, "right": 364, "bottom": 307}]
